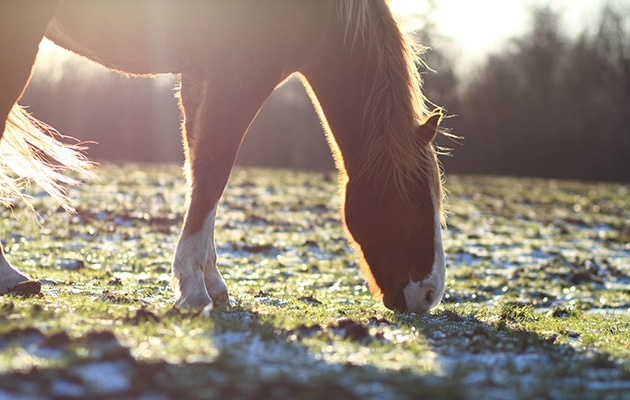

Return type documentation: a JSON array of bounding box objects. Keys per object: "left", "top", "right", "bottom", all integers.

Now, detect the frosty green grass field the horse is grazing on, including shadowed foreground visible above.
[{"left": 0, "top": 165, "right": 630, "bottom": 400}]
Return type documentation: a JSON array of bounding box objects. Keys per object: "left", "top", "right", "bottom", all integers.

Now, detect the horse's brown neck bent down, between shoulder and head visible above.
[{"left": 305, "top": 2, "right": 426, "bottom": 192}]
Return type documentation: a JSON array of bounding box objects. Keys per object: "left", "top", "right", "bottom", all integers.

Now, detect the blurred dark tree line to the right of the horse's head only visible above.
[{"left": 426, "top": 5, "right": 630, "bottom": 182}]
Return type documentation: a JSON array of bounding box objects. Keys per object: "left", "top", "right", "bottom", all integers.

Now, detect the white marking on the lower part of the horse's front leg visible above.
[{"left": 173, "top": 207, "right": 228, "bottom": 308}]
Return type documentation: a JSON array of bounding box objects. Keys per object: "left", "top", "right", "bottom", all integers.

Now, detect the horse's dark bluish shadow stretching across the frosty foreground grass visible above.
[{"left": 0, "top": 307, "right": 628, "bottom": 399}]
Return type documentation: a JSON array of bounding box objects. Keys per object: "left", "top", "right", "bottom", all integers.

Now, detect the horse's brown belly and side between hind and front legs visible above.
[{"left": 46, "top": 0, "right": 330, "bottom": 74}]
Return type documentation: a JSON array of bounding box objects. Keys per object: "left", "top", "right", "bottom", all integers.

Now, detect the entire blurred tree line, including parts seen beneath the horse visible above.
[{"left": 22, "top": 3, "right": 630, "bottom": 182}]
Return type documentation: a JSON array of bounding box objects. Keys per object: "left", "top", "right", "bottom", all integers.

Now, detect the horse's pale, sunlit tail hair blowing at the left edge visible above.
[{"left": 0, "top": 104, "right": 93, "bottom": 212}]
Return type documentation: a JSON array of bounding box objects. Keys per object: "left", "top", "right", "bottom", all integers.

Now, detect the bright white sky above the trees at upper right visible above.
[{"left": 391, "top": 0, "right": 630, "bottom": 63}]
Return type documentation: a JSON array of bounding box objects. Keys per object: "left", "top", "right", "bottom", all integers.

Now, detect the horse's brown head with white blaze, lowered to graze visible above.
[{"left": 344, "top": 116, "right": 445, "bottom": 312}]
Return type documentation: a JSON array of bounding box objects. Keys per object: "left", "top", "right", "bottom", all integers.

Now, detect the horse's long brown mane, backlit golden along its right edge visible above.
[{"left": 338, "top": 0, "right": 445, "bottom": 223}]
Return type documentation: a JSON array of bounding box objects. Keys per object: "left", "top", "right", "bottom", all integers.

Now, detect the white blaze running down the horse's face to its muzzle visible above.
[{"left": 403, "top": 208, "right": 446, "bottom": 312}]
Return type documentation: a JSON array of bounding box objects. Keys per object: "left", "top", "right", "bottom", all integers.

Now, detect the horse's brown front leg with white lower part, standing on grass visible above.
[{"left": 173, "top": 67, "right": 284, "bottom": 307}]
